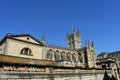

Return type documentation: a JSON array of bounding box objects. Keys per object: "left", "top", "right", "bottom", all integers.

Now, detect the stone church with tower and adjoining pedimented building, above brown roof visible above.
[{"left": 1, "top": 31, "right": 96, "bottom": 68}]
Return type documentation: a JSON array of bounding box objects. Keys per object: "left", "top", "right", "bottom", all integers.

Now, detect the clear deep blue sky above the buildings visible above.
[{"left": 0, "top": 0, "right": 120, "bottom": 54}]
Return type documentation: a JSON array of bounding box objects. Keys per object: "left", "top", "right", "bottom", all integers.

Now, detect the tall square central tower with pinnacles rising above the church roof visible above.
[{"left": 67, "top": 28, "right": 82, "bottom": 49}]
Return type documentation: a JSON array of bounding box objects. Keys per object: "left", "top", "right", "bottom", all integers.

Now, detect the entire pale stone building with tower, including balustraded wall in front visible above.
[{"left": 0, "top": 29, "right": 118, "bottom": 80}]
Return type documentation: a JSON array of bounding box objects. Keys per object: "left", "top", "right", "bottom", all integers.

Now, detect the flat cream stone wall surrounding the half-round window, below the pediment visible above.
[{"left": 6, "top": 39, "right": 42, "bottom": 59}]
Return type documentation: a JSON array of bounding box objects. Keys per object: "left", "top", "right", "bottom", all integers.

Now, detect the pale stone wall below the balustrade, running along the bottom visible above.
[{"left": 0, "top": 70, "right": 111, "bottom": 80}]
